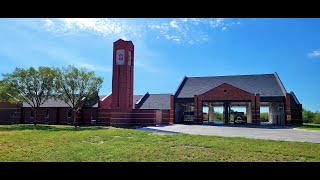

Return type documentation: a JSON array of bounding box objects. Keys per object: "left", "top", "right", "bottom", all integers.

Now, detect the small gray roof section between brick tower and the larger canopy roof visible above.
[{"left": 135, "top": 94, "right": 171, "bottom": 109}]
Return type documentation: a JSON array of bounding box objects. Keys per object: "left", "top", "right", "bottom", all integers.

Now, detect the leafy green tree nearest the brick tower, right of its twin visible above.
[{"left": 56, "top": 66, "right": 103, "bottom": 127}]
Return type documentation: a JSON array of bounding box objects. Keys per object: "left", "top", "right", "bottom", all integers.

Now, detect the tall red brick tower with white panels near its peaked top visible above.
[{"left": 110, "top": 39, "right": 134, "bottom": 126}]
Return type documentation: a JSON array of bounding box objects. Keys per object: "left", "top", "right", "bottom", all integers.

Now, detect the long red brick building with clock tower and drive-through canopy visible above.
[{"left": 0, "top": 39, "right": 302, "bottom": 126}]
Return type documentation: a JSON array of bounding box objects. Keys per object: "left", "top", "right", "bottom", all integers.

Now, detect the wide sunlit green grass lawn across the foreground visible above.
[{"left": 0, "top": 125, "right": 320, "bottom": 162}]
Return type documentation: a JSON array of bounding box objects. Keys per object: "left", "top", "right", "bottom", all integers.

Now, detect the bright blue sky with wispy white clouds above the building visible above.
[{"left": 0, "top": 18, "right": 320, "bottom": 111}]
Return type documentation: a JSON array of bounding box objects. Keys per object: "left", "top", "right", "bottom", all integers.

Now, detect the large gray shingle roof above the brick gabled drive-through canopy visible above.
[{"left": 175, "top": 74, "right": 284, "bottom": 98}]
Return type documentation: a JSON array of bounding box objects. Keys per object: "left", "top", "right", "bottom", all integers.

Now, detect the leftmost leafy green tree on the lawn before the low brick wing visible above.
[{"left": 3, "top": 67, "right": 57, "bottom": 125}]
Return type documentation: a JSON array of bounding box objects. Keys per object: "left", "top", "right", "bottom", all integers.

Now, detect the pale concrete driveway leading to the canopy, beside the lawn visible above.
[{"left": 139, "top": 124, "right": 320, "bottom": 143}]
